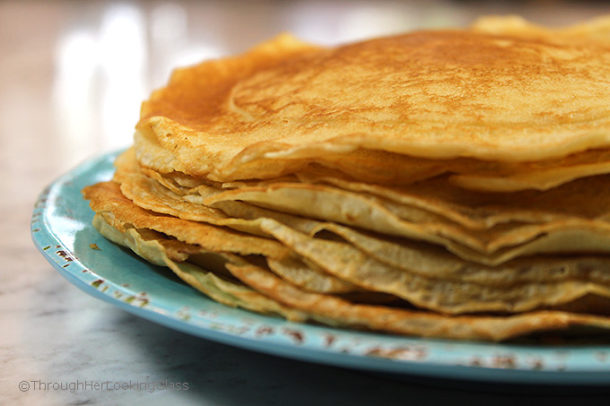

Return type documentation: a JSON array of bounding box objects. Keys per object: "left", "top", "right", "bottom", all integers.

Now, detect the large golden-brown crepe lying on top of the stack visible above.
[{"left": 136, "top": 24, "right": 610, "bottom": 181}]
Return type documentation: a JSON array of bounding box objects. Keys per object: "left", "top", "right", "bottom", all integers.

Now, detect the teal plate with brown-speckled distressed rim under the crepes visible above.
[{"left": 32, "top": 152, "right": 610, "bottom": 385}]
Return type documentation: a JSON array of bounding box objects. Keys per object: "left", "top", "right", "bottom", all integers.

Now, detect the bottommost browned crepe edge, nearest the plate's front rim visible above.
[{"left": 227, "top": 264, "right": 610, "bottom": 341}]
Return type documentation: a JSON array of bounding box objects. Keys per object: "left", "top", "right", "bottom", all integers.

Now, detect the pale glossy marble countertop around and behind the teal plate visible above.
[{"left": 0, "top": 1, "right": 610, "bottom": 406}]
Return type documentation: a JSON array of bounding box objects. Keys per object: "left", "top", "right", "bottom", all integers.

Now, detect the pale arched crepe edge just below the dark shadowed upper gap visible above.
[{"left": 203, "top": 183, "right": 610, "bottom": 255}]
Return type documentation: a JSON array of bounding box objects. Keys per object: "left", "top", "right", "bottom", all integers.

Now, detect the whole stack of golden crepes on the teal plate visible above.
[{"left": 84, "top": 17, "right": 610, "bottom": 340}]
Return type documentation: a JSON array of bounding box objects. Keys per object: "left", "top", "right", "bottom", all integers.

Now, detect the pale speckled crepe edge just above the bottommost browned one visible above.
[{"left": 249, "top": 219, "right": 610, "bottom": 314}]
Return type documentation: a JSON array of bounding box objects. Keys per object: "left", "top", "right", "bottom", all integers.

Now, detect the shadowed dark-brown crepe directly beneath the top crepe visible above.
[{"left": 145, "top": 151, "right": 610, "bottom": 230}]
